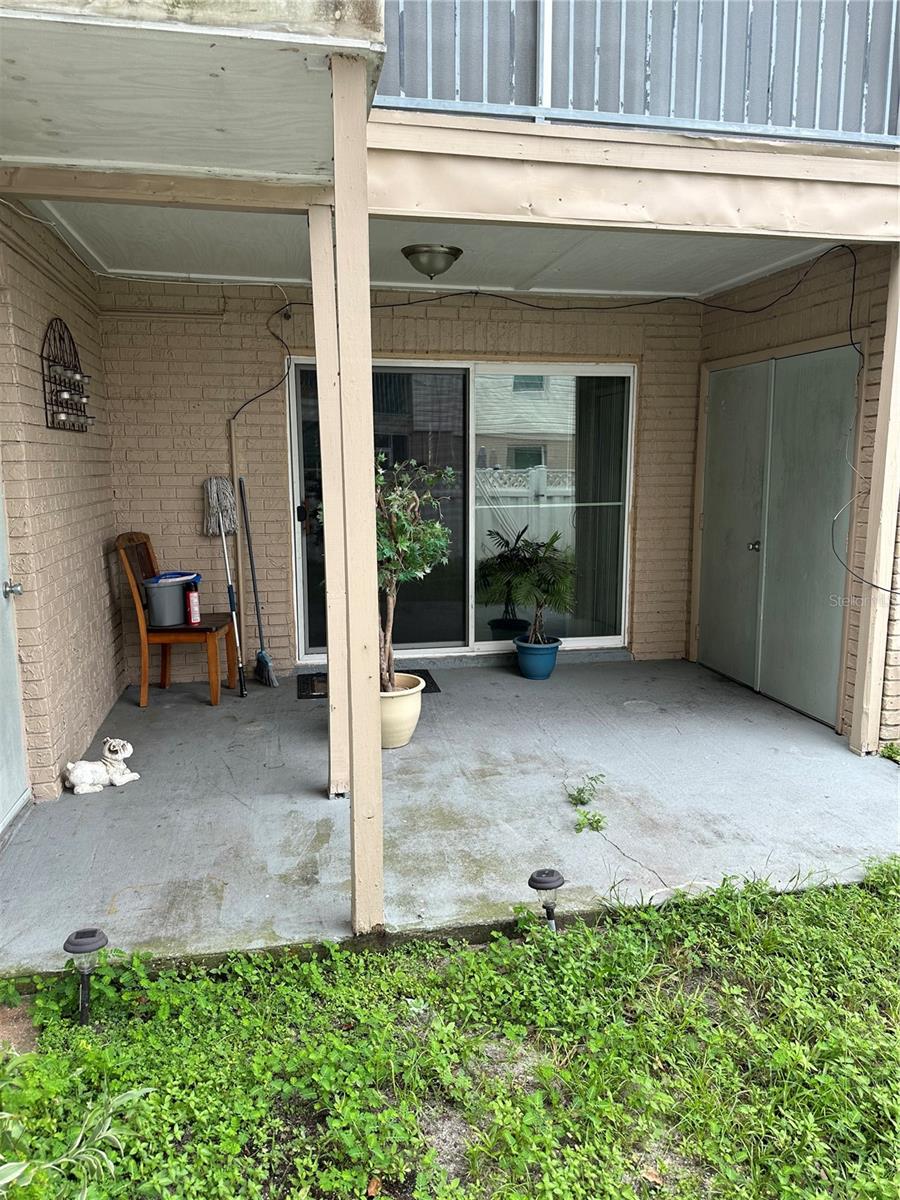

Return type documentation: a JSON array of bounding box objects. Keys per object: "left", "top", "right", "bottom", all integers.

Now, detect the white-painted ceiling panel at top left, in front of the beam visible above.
[{"left": 0, "top": 17, "right": 331, "bottom": 182}]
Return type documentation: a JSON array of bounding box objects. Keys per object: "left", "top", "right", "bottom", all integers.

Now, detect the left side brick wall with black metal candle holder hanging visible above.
[{"left": 0, "top": 208, "right": 122, "bottom": 799}]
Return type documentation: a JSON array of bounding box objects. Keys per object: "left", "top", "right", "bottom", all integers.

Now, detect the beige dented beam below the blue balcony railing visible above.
[{"left": 368, "top": 110, "right": 900, "bottom": 241}]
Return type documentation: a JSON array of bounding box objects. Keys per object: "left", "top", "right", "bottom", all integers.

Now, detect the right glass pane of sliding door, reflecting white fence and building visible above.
[{"left": 474, "top": 367, "right": 631, "bottom": 642}]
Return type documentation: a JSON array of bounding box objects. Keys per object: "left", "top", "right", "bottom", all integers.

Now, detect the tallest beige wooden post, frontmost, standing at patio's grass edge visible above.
[{"left": 331, "top": 55, "right": 384, "bottom": 934}]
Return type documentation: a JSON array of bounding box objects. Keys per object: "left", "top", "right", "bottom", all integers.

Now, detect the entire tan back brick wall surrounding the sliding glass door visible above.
[{"left": 100, "top": 280, "right": 700, "bottom": 680}]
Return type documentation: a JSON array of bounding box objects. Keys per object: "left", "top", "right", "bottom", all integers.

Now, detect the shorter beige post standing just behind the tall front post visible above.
[{"left": 308, "top": 204, "right": 350, "bottom": 796}]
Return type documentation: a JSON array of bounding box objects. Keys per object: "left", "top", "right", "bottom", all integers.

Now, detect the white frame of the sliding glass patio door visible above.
[{"left": 287, "top": 355, "right": 637, "bottom": 666}]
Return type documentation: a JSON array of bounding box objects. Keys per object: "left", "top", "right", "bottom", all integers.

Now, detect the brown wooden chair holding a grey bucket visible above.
[{"left": 115, "top": 533, "right": 238, "bottom": 708}]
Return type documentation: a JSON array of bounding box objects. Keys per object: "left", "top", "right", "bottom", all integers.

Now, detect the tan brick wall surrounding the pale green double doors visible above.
[{"left": 703, "top": 246, "right": 900, "bottom": 739}]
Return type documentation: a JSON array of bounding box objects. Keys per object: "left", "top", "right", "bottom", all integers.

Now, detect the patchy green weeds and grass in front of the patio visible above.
[{"left": 0, "top": 859, "right": 900, "bottom": 1200}]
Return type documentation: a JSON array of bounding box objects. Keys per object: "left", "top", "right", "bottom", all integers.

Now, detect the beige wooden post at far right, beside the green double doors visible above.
[{"left": 850, "top": 246, "right": 900, "bottom": 754}]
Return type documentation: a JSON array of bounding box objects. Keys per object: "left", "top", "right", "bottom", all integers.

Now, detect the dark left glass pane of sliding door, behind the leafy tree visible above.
[{"left": 294, "top": 365, "right": 468, "bottom": 654}]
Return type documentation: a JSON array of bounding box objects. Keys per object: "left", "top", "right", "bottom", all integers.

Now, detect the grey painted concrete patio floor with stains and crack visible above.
[{"left": 0, "top": 662, "right": 900, "bottom": 974}]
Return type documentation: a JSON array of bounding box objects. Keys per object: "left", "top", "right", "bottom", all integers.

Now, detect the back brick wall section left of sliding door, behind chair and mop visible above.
[{"left": 101, "top": 280, "right": 301, "bottom": 703}]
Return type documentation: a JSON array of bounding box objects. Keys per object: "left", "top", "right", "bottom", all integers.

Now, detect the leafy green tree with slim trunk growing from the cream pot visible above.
[{"left": 376, "top": 454, "right": 455, "bottom": 691}]
